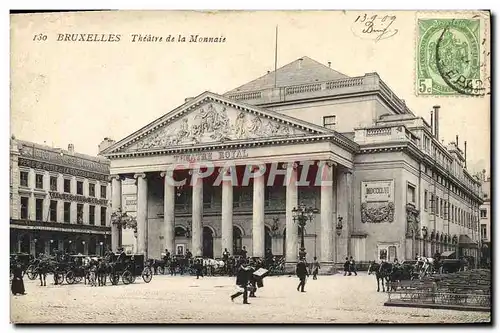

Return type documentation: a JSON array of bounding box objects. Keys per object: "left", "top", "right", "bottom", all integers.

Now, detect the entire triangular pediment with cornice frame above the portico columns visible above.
[{"left": 102, "top": 92, "right": 333, "bottom": 155}]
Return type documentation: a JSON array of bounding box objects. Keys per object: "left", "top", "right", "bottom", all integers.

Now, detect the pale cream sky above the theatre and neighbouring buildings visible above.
[{"left": 11, "top": 11, "right": 490, "bottom": 174}]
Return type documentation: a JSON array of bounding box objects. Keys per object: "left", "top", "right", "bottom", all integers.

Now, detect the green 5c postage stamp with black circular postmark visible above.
[{"left": 416, "top": 18, "right": 485, "bottom": 96}]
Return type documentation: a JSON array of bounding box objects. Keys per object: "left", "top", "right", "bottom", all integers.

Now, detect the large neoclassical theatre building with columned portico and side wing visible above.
[{"left": 101, "top": 57, "right": 482, "bottom": 268}]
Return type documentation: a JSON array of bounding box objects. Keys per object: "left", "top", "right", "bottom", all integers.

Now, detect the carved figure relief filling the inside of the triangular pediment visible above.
[{"left": 137, "top": 103, "right": 299, "bottom": 150}]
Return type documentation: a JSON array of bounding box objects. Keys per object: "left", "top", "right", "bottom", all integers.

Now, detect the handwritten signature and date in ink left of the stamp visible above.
[{"left": 353, "top": 14, "right": 399, "bottom": 42}]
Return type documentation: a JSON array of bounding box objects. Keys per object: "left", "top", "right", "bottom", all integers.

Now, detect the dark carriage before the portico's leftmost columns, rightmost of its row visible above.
[{"left": 109, "top": 254, "right": 153, "bottom": 285}]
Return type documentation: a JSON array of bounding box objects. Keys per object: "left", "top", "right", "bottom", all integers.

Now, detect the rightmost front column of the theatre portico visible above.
[{"left": 320, "top": 161, "right": 335, "bottom": 264}]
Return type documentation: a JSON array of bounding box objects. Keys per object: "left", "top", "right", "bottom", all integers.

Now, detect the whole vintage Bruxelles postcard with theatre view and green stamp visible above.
[{"left": 9, "top": 11, "right": 492, "bottom": 324}]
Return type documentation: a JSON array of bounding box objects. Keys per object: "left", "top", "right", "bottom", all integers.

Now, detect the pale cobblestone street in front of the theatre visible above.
[{"left": 11, "top": 273, "right": 491, "bottom": 323}]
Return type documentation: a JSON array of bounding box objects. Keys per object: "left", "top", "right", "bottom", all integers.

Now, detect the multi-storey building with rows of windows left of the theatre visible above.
[{"left": 10, "top": 136, "right": 111, "bottom": 256}]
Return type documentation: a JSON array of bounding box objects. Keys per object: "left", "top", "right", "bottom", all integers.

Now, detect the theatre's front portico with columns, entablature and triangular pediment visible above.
[{"left": 104, "top": 92, "right": 357, "bottom": 270}]
